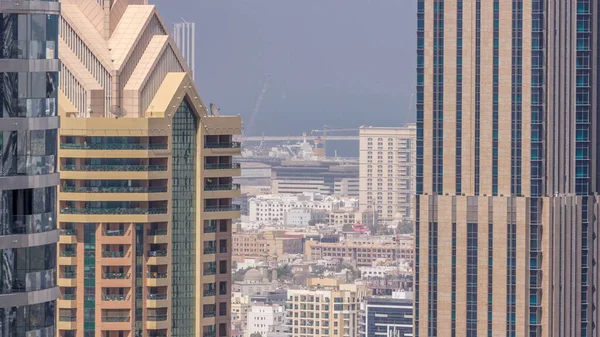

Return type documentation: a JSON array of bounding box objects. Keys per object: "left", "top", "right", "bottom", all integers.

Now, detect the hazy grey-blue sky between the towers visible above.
[{"left": 155, "top": 0, "right": 416, "bottom": 135}]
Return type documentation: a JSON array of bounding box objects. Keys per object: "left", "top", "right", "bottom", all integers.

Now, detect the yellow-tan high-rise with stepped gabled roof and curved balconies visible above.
[{"left": 57, "top": 0, "right": 241, "bottom": 337}]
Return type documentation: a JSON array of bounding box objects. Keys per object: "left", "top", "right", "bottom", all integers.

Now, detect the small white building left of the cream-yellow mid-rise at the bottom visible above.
[{"left": 246, "top": 304, "right": 285, "bottom": 337}]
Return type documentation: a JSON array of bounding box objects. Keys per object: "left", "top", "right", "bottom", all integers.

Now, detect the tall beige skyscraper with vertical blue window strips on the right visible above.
[{"left": 415, "top": 0, "right": 600, "bottom": 336}]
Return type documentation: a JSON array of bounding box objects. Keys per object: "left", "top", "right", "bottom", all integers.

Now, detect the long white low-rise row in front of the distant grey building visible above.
[{"left": 248, "top": 193, "right": 356, "bottom": 221}]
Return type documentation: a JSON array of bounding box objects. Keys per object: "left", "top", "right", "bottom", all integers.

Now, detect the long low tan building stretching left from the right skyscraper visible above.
[{"left": 304, "top": 240, "right": 413, "bottom": 266}]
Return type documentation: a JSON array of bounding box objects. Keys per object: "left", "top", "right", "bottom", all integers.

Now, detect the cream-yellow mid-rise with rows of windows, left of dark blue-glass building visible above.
[{"left": 286, "top": 278, "right": 367, "bottom": 337}]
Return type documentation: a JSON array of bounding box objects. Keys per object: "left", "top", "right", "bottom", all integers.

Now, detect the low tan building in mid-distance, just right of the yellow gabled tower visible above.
[{"left": 232, "top": 231, "right": 304, "bottom": 262}]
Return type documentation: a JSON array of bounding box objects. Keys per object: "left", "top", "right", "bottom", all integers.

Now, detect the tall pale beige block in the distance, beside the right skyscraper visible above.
[{"left": 359, "top": 124, "right": 417, "bottom": 222}]
